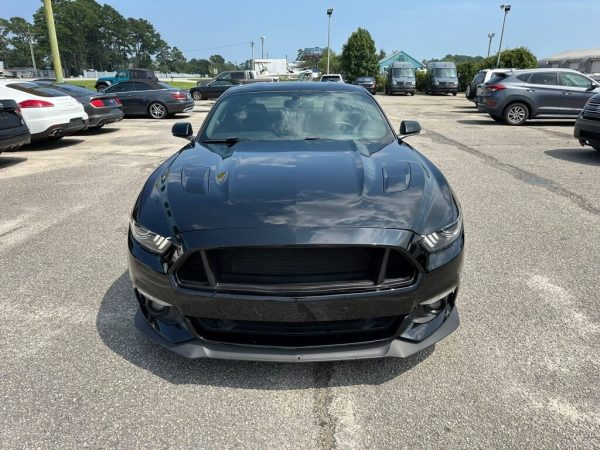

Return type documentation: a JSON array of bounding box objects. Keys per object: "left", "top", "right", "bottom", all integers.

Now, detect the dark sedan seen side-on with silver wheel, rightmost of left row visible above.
[{"left": 105, "top": 80, "right": 194, "bottom": 119}]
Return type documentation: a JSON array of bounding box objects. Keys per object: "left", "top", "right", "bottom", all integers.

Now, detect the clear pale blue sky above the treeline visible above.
[{"left": 0, "top": 0, "right": 600, "bottom": 62}]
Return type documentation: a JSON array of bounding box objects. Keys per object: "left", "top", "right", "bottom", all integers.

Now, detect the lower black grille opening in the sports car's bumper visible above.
[{"left": 190, "top": 316, "right": 403, "bottom": 347}]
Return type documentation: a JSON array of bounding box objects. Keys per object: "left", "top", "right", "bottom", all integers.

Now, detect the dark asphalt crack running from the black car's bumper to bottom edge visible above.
[{"left": 313, "top": 363, "right": 335, "bottom": 450}]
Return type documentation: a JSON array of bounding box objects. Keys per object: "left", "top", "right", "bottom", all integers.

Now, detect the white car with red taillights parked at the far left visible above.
[{"left": 0, "top": 80, "right": 88, "bottom": 141}]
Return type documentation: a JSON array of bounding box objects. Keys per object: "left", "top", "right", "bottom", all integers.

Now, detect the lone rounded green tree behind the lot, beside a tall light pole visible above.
[{"left": 341, "top": 28, "right": 379, "bottom": 80}]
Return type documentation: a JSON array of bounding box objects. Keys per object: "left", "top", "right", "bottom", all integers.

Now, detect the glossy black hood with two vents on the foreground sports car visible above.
[{"left": 134, "top": 141, "right": 456, "bottom": 236}]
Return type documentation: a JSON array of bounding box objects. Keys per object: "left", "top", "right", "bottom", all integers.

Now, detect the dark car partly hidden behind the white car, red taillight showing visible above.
[{"left": 36, "top": 81, "right": 123, "bottom": 128}]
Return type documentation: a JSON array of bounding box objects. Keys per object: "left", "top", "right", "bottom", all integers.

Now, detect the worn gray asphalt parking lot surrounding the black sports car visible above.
[{"left": 0, "top": 95, "right": 600, "bottom": 449}]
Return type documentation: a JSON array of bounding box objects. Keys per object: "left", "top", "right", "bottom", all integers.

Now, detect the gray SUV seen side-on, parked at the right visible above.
[{"left": 477, "top": 69, "right": 600, "bottom": 125}]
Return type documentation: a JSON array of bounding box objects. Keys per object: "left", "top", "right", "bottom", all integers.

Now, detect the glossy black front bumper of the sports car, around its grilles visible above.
[{"left": 129, "top": 229, "right": 463, "bottom": 361}]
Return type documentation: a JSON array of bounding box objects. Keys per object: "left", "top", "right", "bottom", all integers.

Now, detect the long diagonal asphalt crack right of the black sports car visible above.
[{"left": 423, "top": 130, "right": 600, "bottom": 216}]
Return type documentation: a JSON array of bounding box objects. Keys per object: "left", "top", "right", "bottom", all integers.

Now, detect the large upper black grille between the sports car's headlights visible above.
[{"left": 176, "top": 246, "right": 416, "bottom": 294}]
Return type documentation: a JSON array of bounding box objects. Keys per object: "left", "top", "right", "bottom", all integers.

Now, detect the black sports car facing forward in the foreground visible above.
[{"left": 128, "top": 83, "right": 464, "bottom": 361}]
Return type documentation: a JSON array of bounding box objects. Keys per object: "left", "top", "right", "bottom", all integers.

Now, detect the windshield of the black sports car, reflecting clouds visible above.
[{"left": 200, "top": 91, "right": 394, "bottom": 151}]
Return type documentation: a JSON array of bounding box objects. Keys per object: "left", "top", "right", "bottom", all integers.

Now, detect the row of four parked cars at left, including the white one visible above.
[{"left": 0, "top": 79, "right": 194, "bottom": 151}]
